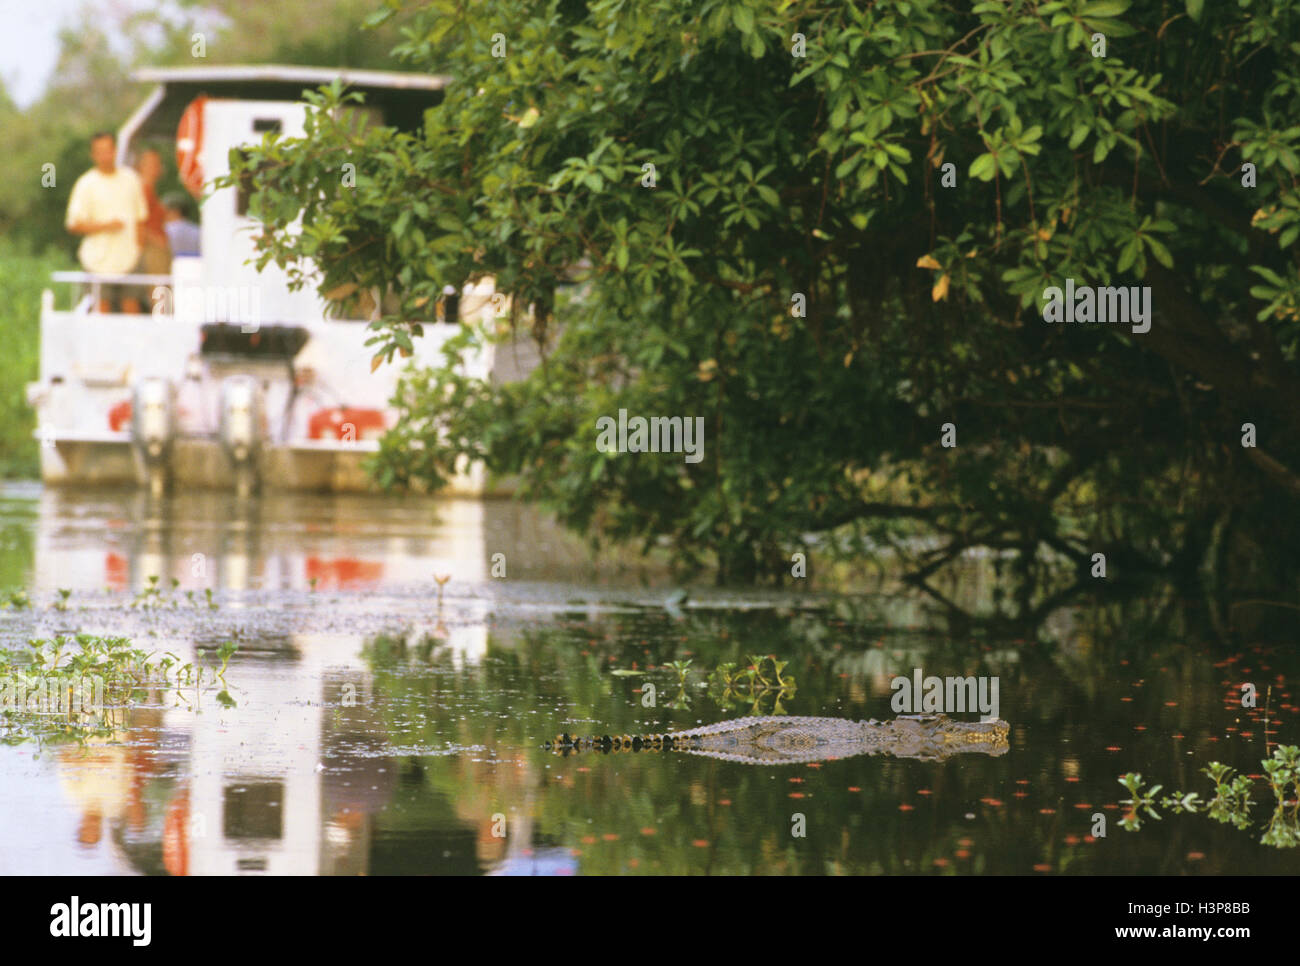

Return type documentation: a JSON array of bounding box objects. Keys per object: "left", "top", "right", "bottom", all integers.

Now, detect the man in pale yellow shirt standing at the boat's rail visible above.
[{"left": 65, "top": 131, "right": 148, "bottom": 315}]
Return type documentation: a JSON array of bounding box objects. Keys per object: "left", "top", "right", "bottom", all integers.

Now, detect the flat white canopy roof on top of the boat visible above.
[{"left": 124, "top": 64, "right": 451, "bottom": 138}]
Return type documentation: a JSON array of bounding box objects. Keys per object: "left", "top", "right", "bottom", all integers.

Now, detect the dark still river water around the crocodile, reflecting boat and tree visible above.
[{"left": 0, "top": 485, "right": 1300, "bottom": 875}]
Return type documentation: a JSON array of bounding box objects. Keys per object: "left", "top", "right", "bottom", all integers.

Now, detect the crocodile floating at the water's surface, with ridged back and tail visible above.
[{"left": 543, "top": 715, "right": 1010, "bottom": 764}]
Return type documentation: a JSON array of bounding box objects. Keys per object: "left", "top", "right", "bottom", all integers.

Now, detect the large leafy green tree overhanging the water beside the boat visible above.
[{"left": 228, "top": 0, "right": 1300, "bottom": 590}]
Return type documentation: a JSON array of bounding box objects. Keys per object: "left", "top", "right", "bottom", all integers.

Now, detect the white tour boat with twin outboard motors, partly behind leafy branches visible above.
[{"left": 27, "top": 66, "right": 536, "bottom": 495}]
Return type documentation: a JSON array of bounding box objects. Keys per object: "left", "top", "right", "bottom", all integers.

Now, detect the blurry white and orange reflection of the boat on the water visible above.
[{"left": 17, "top": 488, "right": 600, "bottom": 875}]
